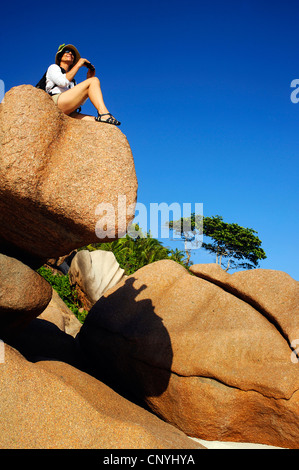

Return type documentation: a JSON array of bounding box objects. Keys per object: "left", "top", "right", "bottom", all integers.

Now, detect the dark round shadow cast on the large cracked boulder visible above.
[{"left": 76, "top": 277, "right": 173, "bottom": 403}]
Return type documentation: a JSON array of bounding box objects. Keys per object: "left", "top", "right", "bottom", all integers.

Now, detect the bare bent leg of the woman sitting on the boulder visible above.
[{"left": 57, "top": 77, "right": 109, "bottom": 114}]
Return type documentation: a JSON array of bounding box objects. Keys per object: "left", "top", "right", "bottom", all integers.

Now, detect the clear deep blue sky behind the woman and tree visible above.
[{"left": 0, "top": 0, "right": 299, "bottom": 280}]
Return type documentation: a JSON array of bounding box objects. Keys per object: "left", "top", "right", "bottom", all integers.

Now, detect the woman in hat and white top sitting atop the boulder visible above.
[{"left": 46, "top": 44, "right": 120, "bottom": 126}]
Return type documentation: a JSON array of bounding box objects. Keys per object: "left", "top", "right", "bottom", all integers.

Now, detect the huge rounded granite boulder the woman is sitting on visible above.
[{"left": 0, "top": 85, "right": 137, "bottom": 259}]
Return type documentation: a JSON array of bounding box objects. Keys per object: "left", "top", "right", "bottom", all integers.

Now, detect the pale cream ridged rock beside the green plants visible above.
[{"left": 68, "top": 250, "right": 124, "bottom": 310}]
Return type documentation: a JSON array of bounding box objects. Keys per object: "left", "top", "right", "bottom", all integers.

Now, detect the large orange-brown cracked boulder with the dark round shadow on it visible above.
[{"left": 77, "top": 260, "right": 299, "bottom": 448}]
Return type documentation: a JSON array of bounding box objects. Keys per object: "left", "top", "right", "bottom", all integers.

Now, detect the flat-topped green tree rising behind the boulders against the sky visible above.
[{"left": 167, "top": 213, "right": 266, "bottom": 271}]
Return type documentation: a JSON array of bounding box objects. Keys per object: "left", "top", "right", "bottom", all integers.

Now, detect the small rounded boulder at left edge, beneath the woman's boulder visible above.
[{"left": 0, "top": 254, "right": 52, "bottom": 338}]
